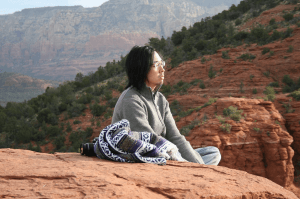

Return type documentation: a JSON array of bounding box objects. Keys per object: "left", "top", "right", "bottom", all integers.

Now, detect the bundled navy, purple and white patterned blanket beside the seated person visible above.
[{"left": 94, "top": 119, "right": 186, "bottom": 165}]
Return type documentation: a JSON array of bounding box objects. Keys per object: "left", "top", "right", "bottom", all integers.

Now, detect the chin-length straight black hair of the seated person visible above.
[{"left": 125, "top": 46, "right": 155, "bottom": 90}]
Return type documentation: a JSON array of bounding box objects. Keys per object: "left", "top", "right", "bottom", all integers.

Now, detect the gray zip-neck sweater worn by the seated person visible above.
[{"left": 112, "top": 85, "right": 204, "bottom": 164}]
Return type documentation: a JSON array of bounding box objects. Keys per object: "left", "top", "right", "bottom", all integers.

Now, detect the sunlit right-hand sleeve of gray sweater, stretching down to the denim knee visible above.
[{"left": 164, "top": 101, "right": 204, "bottom": 164}]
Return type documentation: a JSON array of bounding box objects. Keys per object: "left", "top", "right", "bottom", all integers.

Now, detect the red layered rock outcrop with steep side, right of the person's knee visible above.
[{"left": 177, "top": 98, "right": 294, "bottom": 187}]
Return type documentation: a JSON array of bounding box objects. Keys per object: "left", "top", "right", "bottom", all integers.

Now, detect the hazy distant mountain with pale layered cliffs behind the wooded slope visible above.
[{"left": 0, "top": 0, "right": 240, "bottom": 81}]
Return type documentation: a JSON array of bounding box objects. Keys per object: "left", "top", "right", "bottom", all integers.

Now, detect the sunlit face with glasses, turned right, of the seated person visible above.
[{"left": 146, "top": 51, "right": 165, "bottom": 90}]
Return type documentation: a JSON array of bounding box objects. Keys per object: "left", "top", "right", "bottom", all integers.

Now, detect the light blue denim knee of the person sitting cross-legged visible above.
[{"left": 195, "top": 146, "right": 221, "bottom": 165}]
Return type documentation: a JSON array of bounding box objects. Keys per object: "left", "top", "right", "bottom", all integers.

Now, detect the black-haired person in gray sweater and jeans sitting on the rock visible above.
[{"left": 112, "top": 46, "right": 221, "bottom": 165}]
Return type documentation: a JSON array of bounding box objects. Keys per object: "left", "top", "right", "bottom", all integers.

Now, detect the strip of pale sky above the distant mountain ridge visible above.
[{"left": 0, "top": 0, "right": 108, "bottom": 15}]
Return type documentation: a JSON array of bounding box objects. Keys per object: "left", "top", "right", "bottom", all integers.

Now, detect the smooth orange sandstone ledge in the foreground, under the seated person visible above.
[{"left": 0, "top": 149, "right": 297, "bottom": 199}]
